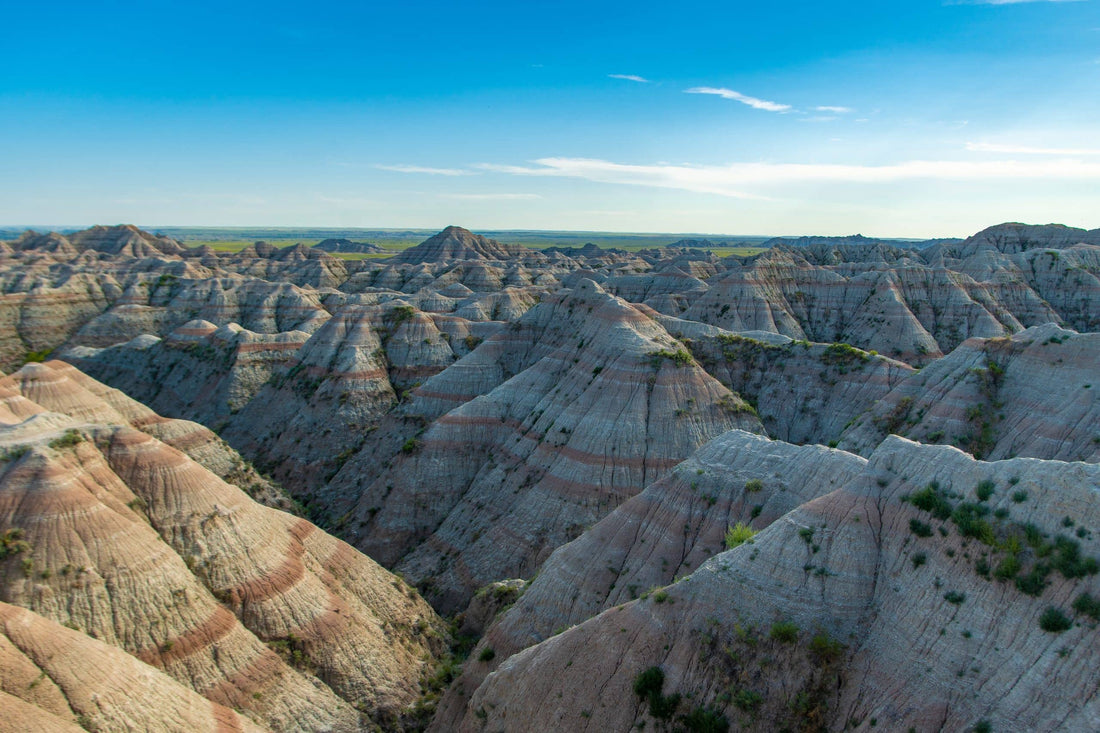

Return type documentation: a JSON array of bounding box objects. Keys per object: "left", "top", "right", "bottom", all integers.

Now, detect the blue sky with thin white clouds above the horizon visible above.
[{"left": 0, "top": 0, "right": 1100, "bottom": 237}]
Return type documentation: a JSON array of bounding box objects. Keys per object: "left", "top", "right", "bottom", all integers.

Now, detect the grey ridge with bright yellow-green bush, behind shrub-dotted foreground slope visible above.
[{"left": 435, "top": 430, "right": 867, "bottom": 730}]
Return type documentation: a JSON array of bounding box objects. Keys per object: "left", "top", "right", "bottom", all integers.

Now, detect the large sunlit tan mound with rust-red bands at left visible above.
[{"left": 0, "top": 362, "right": 442, "bottom": 730}]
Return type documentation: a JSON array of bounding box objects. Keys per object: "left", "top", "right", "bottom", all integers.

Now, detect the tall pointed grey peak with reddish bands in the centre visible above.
[{"left": 330, "top": 281, "right": 760, "bottom": 610}]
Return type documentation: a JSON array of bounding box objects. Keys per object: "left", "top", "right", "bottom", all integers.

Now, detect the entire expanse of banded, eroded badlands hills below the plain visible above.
[{"left": 0, "top": 223, "right": 1100, "bottom": 732}]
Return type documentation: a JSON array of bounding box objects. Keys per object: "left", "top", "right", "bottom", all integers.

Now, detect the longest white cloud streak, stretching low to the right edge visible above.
[{"left": 476, "top": 157, "right": 1100, "bottom": 199}]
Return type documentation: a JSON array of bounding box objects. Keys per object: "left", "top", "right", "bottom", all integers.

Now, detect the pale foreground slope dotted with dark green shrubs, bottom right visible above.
[{"left": 444, "top": 437, "right": 1100, "bottom": 731}]
